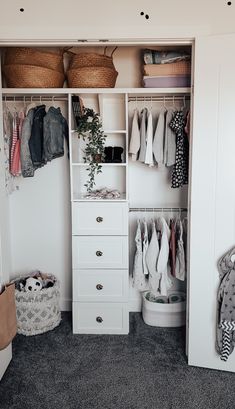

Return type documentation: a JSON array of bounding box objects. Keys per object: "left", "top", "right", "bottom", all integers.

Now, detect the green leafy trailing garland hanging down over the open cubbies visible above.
[{"left": 76, "top": 108, "right": 106, "bottom": 192}]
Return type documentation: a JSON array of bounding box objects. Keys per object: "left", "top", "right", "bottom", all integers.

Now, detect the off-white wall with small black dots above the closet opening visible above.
[{"left": 0, "top": 0, "right": 235, "bottom": 41}]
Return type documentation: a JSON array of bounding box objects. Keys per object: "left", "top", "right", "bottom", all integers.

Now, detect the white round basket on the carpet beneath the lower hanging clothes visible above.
[{"left": 142, "top": 291, "right": 186, "bottom": 327}]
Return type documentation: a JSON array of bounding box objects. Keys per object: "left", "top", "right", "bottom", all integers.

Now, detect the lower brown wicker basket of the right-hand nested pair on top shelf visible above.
[{"left": 67, "top": 67, "right": 118, "bottom": 88}]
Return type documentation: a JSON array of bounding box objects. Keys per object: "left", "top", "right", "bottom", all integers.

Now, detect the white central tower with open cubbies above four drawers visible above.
[{"left": 69, "top": 91, "right": 129, "bottom": 334}]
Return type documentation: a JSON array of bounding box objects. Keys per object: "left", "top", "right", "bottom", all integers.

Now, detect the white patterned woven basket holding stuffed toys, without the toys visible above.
[{"left": 15, "top": 275, "right": 61, "bottom": 335}]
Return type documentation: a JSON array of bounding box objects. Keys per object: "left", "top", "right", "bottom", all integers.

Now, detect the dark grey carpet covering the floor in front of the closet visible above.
[{"left": 0, "top": 313, "right": 235, "bottom": 409}]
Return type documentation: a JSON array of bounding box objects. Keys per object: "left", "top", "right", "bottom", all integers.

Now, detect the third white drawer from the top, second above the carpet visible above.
[{"left": 73, "top": 270, "right": 129, "bottom": 302}]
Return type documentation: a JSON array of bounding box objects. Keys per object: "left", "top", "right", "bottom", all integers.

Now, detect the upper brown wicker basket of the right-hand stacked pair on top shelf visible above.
[{"left": 69, "top": 53, "right": 115, "bottom": 69}]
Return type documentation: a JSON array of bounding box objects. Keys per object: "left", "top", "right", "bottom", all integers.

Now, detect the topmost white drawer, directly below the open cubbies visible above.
[{"left": 72, "top": 202, "right": 128, "bottom": 236}]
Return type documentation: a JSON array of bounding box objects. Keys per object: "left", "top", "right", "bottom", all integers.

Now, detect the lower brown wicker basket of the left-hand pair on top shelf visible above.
[{"left": 3, "top": 64, "right": 64, "bottom": 88}]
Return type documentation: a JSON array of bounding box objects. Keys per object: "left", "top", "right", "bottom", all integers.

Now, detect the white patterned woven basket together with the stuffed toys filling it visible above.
[{"left": 14, "top": 271, "right": 61, "bottom": 335}]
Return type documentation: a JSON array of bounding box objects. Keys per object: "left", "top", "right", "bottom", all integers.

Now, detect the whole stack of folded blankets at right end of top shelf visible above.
[{"left": 143, "top": 49, "right": 191, "bottom": 88}]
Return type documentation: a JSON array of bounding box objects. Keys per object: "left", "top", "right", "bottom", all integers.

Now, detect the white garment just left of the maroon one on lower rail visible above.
[{"left": 157, "top": 217, "right": 173, "bottom": 296}]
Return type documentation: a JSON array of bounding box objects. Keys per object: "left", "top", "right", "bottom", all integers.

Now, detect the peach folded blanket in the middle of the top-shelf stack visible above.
[{"left": 144, "top": 61, "right": 191, "bottom": 77}]
